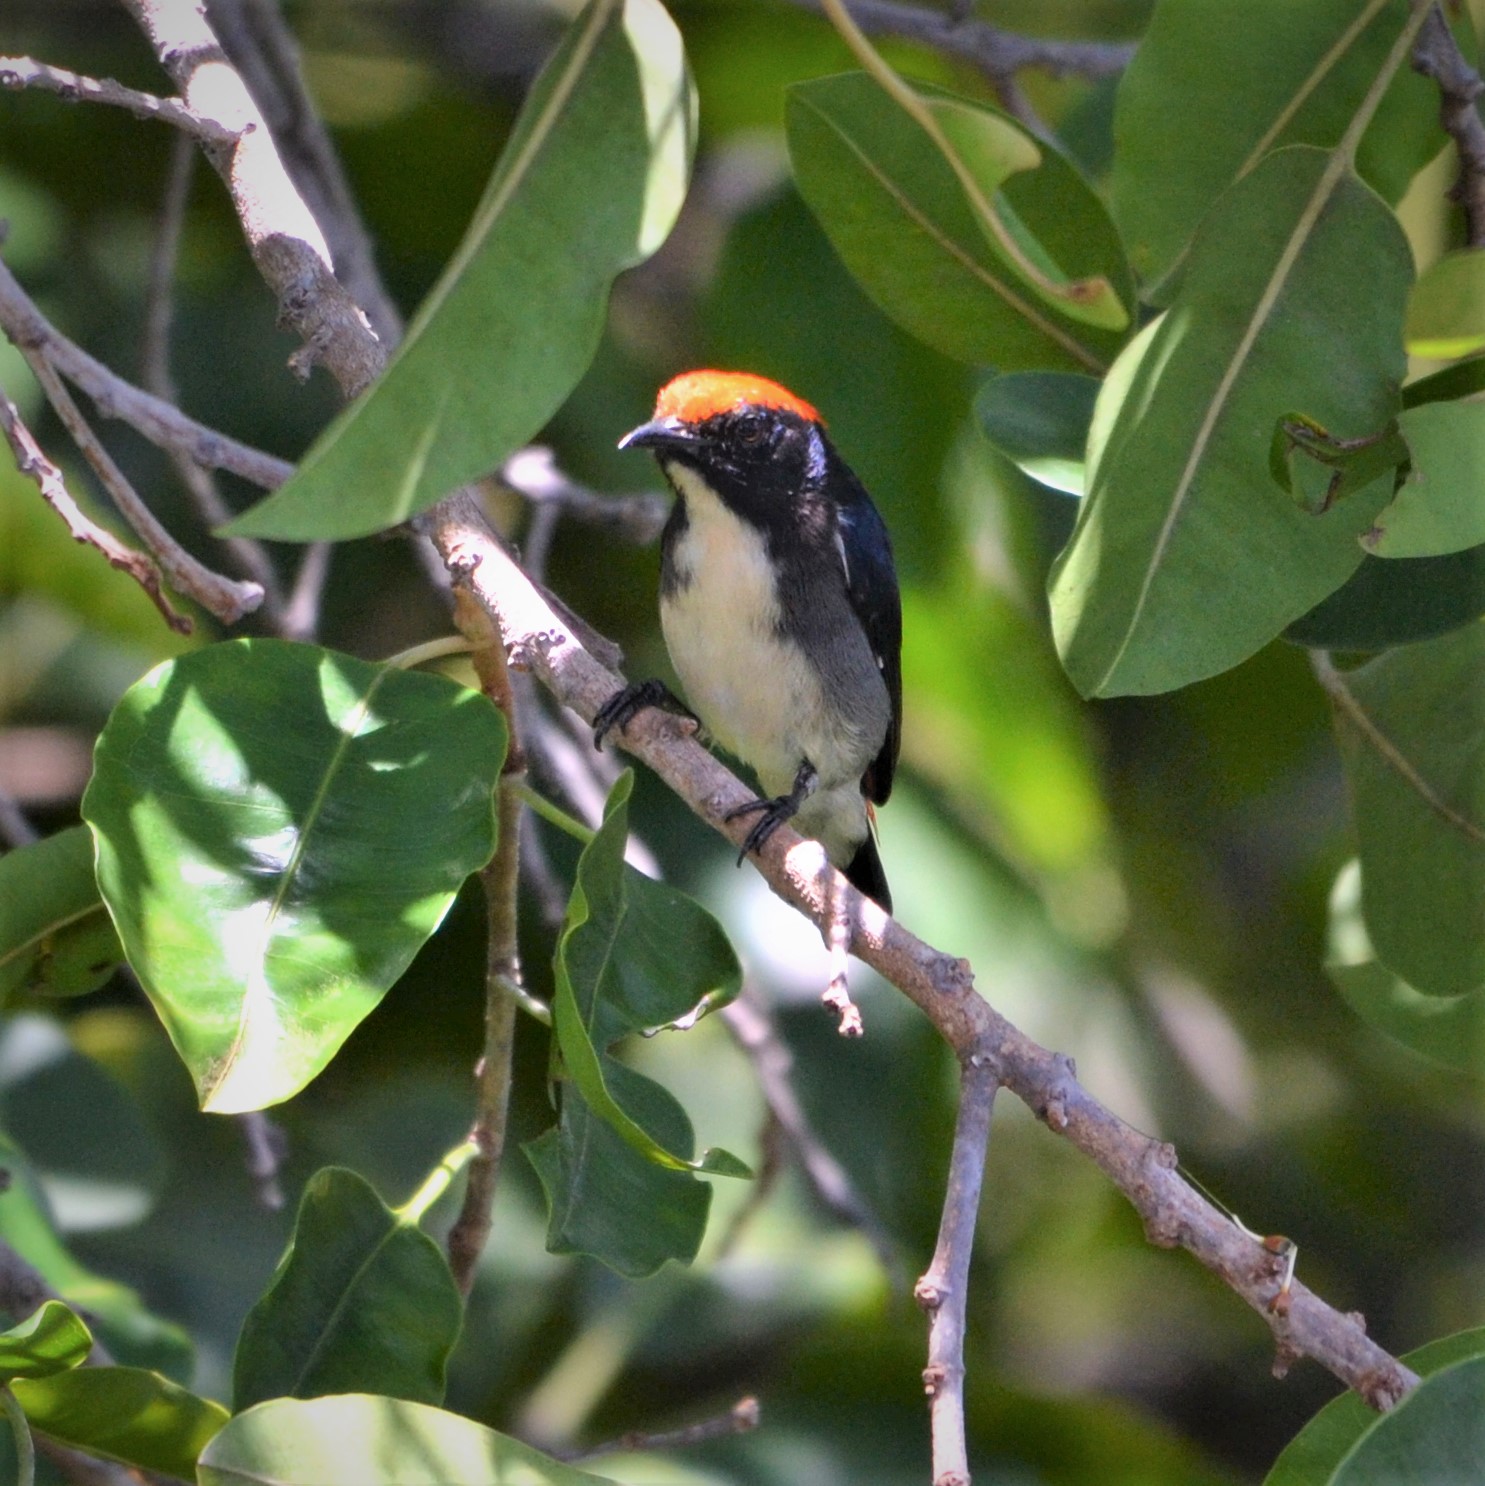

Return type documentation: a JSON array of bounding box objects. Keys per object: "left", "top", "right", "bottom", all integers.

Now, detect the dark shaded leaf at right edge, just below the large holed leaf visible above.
[{"left": 1284, "top": 544, "right": 1485, "bottom": 651}]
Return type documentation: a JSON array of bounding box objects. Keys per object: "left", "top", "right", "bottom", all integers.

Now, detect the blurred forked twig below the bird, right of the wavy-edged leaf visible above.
[{"left": 718, "top": 987, "right": 902, "bottom": 1279}]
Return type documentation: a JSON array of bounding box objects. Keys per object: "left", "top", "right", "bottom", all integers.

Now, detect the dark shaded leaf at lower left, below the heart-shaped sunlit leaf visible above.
[{"left": 232, "top": 1167, "right": 464, "bottom": 1412}]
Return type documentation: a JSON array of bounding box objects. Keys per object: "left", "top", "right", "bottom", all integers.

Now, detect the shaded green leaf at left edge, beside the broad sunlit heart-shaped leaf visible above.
[{"left": 0, "top": 826, "right": 123, "bottom": 999}]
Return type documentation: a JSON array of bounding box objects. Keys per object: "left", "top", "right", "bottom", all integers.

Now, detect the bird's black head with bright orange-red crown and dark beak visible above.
[{"left": 620, "top": 372, "right": 828, "bottom": 528}]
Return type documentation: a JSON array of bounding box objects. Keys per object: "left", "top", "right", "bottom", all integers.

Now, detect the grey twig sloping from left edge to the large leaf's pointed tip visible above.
[{"left": 0, "top": 252, "right": 294, "bottom": 490}]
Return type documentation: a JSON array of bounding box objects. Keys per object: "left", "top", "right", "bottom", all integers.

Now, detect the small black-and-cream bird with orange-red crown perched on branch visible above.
[{"left": 593, "top": 370, "right": 902, "bottom": 912}]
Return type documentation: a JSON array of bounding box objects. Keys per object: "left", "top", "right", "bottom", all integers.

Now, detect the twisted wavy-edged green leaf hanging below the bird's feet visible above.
[{"left": 528, "top": 771, "right": 751, "bottom": 1274}]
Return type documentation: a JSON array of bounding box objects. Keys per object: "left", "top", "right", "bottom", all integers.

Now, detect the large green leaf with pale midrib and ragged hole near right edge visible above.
[{"left": 1051, "top": 147, "right": 1412, "bottom": 697}]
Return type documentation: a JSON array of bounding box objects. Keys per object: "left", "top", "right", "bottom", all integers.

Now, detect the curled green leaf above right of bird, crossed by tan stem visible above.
[{"left": 785, "top": 73, "right": 1133, "bottom": 372}]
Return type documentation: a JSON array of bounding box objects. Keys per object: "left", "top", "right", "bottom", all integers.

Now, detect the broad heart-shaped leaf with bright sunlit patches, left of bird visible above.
[{"left": 83, "top": 640, "right": 505, "bottom": 1113}]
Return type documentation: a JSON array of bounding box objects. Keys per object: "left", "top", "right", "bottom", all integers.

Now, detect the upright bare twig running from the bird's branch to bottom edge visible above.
[{"left": 913, "top": 1052, "right": 999, "bottom": 1486}]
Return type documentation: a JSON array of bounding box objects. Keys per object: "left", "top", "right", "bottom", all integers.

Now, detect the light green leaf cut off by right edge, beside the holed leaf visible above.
[{"left": 1362, "top": 403, "right": 1485, "bottom": 557}]
